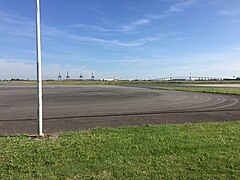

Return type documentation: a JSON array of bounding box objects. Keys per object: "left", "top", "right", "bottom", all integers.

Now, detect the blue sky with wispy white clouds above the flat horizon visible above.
[{"left": 0, "top": 0, "right": 240, "bottom": 79}]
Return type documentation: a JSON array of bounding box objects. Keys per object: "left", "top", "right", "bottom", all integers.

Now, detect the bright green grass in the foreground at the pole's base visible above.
[{"left": 0, "top": 122, "right": 240, "bottom": 179}]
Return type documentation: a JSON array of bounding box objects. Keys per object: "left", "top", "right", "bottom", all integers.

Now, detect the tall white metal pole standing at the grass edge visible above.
[{"left": 36, "top": 0, "right": 44, "bottom": 136}]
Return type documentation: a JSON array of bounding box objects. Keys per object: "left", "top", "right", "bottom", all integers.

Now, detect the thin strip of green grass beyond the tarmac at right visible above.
[{"left": 154, "top": 87, "right": 240, "bottom": 94}]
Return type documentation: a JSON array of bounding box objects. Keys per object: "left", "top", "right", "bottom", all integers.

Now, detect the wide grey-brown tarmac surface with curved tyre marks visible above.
[{"left": 0, "top": 84, "right": 240, "bottom": 134}]
